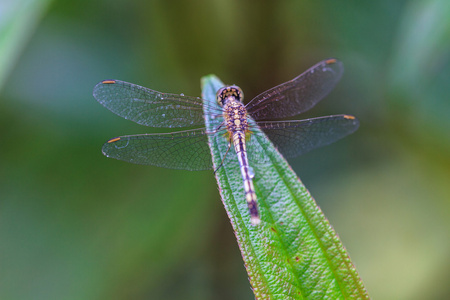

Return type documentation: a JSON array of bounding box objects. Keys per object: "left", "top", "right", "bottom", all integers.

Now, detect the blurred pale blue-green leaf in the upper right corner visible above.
[{"left": 389, "top": 0, "right": 450, "bottom": 90}]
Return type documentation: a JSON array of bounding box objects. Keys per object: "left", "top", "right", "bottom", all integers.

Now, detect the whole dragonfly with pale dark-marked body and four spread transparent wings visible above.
[{"left": 93, "top": 58, "right": 359, "bottom": 225}]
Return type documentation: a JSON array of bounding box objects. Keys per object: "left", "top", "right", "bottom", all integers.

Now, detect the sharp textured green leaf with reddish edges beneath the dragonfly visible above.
[{"left": 202, "top": 75, "right": 369, "bottom": 299}]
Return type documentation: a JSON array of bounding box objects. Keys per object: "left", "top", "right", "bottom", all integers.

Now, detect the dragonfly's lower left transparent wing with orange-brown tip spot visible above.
[{"left": 102, "top": 129, "right": 212, "bottom": 171}]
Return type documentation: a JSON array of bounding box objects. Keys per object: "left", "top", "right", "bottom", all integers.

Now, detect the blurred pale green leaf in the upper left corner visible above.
[{"left": 0, "top": 0, "right": 51, "bottom": 89}]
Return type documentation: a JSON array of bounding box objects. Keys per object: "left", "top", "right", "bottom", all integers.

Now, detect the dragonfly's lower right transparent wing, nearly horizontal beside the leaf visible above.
[{"left": 253, "top": 115, "right": 359, "bottom": 157}]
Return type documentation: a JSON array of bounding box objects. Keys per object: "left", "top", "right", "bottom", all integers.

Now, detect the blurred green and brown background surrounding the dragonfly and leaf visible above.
[{"left": 0, "top": 0, "right": 450, "bottom": 300}]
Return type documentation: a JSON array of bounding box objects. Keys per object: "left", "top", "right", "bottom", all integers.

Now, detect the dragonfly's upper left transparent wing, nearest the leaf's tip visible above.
[{"left": 94, "top": 80, "right": 205, "bottom": 128}]
